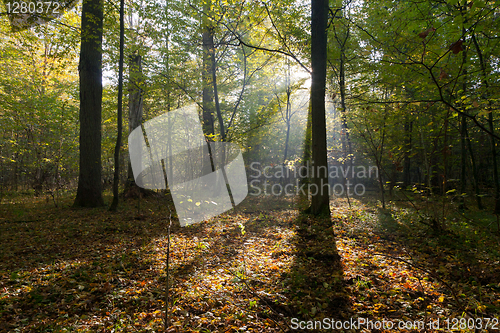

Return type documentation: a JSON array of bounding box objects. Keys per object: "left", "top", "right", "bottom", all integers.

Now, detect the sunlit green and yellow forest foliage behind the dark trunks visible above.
[{"left": 0, "top": 1, "right": 500, "bottom": 212}]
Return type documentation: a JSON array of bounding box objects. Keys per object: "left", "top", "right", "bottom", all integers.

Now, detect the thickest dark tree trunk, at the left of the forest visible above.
[{"left": 74, "top": 0, "right": 104, "bottom": 207}]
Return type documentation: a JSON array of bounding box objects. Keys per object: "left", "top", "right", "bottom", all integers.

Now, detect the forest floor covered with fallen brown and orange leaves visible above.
[{"left": 0, "top": 188, "right": 500, "bottom": 333}]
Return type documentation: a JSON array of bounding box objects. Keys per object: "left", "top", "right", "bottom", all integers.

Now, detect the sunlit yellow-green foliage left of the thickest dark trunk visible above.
[{"left": 0, "top": 18, "right": 80, "bottom": 197}]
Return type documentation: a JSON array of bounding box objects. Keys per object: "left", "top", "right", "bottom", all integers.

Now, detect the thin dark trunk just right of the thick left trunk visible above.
[{"left": 109, "top": 0, "right": 125, "bottom": 212}]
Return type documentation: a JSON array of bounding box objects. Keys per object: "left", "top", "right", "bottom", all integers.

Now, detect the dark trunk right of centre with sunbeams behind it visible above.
[{"left": 309, "top": 0, "right": 330, "bottom": 216}]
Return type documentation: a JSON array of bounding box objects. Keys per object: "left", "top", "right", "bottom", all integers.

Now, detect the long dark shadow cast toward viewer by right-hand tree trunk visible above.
[{"left": 283, "top": 215, "right": 352, "bottom": 331}]
